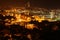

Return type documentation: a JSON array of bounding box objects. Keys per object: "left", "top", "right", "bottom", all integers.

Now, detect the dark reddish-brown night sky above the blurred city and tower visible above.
[{"left": 0, "top": 0, "right": 60, "bottom": 8}]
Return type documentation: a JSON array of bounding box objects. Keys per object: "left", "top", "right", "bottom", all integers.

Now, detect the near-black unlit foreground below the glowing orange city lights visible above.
[{"left": 0, "top": 21, "right": 60, "bottom": 40}]
